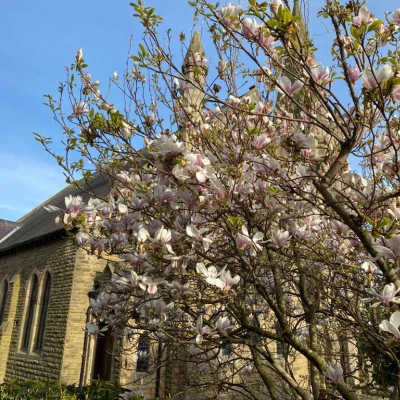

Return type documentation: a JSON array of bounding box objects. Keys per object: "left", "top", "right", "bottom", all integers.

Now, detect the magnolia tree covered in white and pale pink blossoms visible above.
[{"left": 38, "top": 0, "right": 400, "bottom": 400}]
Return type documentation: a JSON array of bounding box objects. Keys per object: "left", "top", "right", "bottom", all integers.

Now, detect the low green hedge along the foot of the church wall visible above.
[{"left": 0, "top": 379, "right": 142, "bottom": 400}]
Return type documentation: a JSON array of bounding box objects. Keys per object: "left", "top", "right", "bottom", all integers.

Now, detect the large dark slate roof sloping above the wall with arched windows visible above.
[{"left": 0, "top": 173, "right": 110, "bottom": 254}]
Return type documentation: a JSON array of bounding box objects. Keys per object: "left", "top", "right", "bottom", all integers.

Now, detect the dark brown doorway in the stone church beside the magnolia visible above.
[{"left": 92, "top": 329, "right": 114, "bottom": 381}]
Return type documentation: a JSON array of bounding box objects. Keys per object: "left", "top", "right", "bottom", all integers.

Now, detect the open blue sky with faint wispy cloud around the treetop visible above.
[{"left": 0, "top": 0, "right": 398, "bottom": 221}]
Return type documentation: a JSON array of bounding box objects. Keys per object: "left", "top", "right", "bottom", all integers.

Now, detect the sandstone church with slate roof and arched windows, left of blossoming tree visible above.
[{"left": 0, "top": 174, "right": 164, "bottom": 398}]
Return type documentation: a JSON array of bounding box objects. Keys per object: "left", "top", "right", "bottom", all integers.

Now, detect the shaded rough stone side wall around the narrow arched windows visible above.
[{"left": 0, "top": 239, "right": 77, "bottom": 381}]
